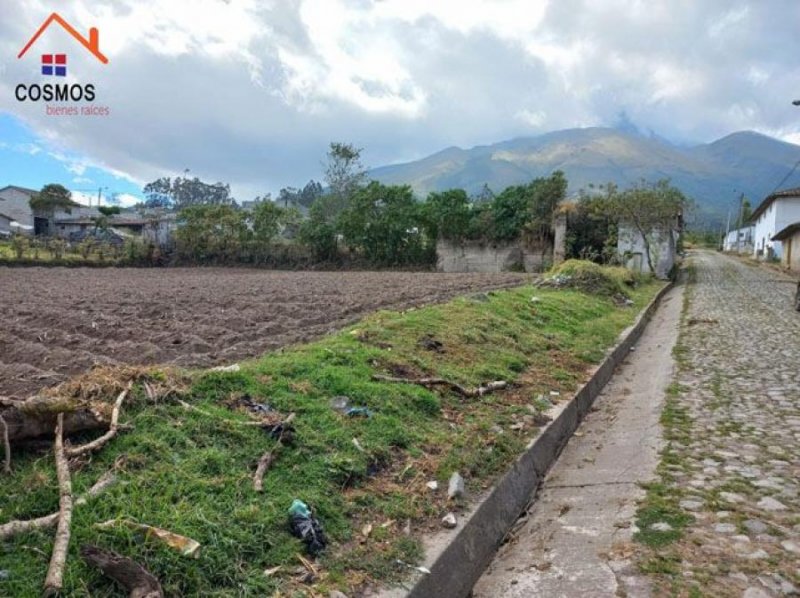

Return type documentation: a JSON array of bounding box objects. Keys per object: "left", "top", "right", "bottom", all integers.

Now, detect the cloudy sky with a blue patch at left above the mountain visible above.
[{"left": 0, "top": 0, "right": 800, "bottom": 200}]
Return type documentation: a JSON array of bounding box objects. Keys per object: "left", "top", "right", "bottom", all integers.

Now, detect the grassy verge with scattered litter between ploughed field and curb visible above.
[{"left": 0, "top": 283, "right": 661, "bottom": 596}]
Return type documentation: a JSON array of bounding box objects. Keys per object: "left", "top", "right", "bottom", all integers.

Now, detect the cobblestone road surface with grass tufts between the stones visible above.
[{"left": 640, "top": 252, "right": 800, "bottom": 598}]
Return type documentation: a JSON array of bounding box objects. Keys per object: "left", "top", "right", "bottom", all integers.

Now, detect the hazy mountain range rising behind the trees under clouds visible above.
[{"left": 370, "top": 127, "right": 800, "bottom": 226}]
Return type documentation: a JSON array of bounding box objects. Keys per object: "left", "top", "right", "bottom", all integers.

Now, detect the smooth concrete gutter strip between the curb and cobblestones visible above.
[{"left": 473, "top": 287, "right": 683, "bottom": 598}]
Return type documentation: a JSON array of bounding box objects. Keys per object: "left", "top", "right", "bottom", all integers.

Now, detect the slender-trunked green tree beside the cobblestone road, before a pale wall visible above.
[{"left": 606, "top": 179, "right": 689, "bottom": 274}]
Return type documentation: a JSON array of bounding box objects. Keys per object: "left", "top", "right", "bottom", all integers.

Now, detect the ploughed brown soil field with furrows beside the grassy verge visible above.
[{"left": 0, "top": 268, "right": 530, "bottom": 397}]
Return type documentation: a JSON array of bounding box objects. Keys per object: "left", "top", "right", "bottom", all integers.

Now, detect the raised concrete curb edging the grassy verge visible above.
[{"left": 381, "top": 283, "right": 673, "bottom": 598}]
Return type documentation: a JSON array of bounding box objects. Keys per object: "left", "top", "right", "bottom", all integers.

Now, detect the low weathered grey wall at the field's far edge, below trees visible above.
[{"left": 436, "top": 239, "right": 553, "bottom": 272}]
